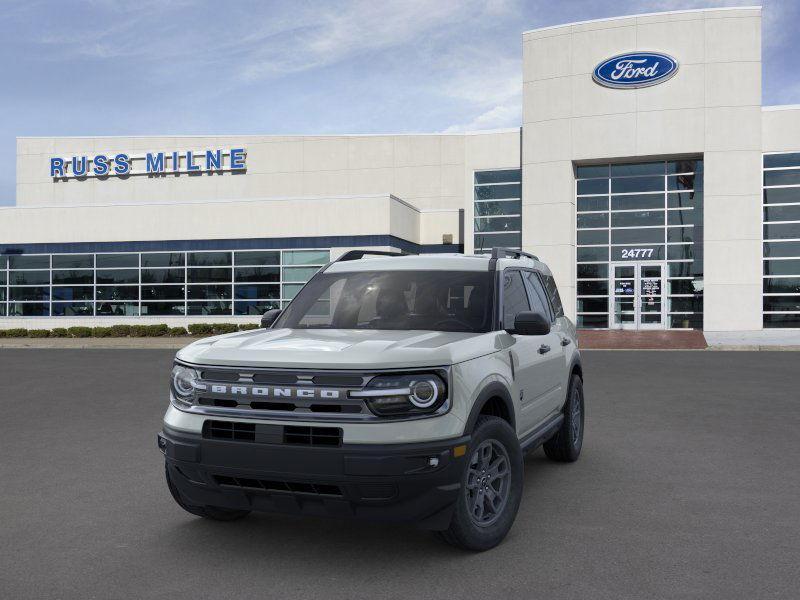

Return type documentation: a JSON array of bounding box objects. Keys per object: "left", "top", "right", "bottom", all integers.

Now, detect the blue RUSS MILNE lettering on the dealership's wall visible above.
[{"left": 50, "top": 148, "right": 247, "bottom": 179}]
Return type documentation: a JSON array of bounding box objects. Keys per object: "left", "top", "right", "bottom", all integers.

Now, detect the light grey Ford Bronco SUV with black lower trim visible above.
[{"left": 158, "top": 249, "right": 584, "bottom": 550}]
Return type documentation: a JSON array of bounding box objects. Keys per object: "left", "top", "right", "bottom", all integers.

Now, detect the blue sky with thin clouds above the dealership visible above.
[{"left": 0, "top": 0, "right": 800, "bottom": 205}]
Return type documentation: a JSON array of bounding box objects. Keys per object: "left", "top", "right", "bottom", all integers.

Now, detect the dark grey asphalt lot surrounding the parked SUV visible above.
[{"left": 0, "top": 349, "right": 800, "bottom": 600}]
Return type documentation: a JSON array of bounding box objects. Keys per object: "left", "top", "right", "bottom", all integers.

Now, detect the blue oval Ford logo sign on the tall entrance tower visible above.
[{"left": 592, "top": 52, "right": 678, "bottom": 88}]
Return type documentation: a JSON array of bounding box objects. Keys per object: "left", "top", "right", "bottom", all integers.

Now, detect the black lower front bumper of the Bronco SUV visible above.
[{"left": 158, "top": 425, "right": 469, "bottom": 530}]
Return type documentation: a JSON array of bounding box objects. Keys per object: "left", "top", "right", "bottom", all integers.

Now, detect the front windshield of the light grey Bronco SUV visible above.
[{"left": 274, "top": 271, "right": 493, "bottom": 333}]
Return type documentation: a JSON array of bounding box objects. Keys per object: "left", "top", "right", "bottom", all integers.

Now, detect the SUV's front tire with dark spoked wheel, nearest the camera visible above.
[{"left": 438, "top": 416, "right": 523, "bottom": 552}]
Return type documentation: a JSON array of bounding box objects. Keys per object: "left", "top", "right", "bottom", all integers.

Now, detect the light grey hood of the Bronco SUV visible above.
[{"left": 177, "top": 329, "right": 499, "bottom": 370}]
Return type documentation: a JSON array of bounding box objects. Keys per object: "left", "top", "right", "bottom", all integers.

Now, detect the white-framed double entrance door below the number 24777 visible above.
[{"left": 609, "top": 262, "right": 666, "bottom": 329}]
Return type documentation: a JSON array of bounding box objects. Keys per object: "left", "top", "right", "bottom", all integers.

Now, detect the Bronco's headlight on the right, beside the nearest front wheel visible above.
[{"left": 350, "top": 373, "right": 447, "bottom": 417}]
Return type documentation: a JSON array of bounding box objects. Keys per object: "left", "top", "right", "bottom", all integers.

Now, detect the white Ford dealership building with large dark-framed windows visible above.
[{"left": 0, "top": 7, "right": 800, "bottom": 332}]
